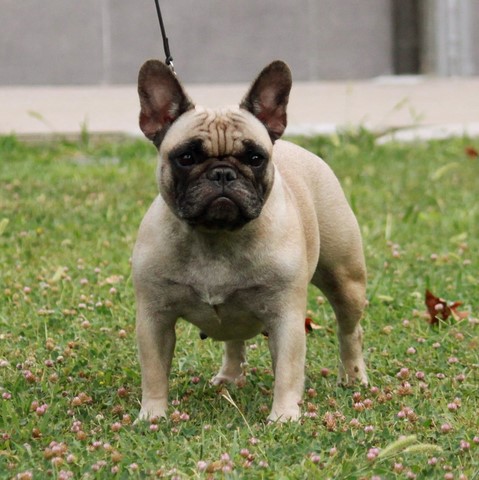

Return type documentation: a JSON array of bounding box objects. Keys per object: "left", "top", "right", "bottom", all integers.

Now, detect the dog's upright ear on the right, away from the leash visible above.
[{"left": 240, "top": 60, "right": 292, "bottom": 142}]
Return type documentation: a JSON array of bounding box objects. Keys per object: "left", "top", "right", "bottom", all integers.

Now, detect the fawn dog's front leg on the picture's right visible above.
[{"left": 268, "top": 314, "right": 306, "bottom": 422}]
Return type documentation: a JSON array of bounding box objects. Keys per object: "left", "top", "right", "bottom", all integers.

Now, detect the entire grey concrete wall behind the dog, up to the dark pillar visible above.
[{"left": 0, "top": 0, "right": 392, "bottom": 85}]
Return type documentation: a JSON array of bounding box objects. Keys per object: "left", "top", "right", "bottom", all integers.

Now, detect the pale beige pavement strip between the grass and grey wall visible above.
[{"left": 0, "top": 77, "right": 479, "bottom": 140}]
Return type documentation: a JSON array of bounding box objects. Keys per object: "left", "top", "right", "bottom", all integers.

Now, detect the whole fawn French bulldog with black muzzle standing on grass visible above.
[{"left": 132, "top": 60, "right": 367, "bottom": 421}]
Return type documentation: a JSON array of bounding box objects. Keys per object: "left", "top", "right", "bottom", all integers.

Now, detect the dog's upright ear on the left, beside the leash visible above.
[{"left": 138, "top": 60, "right": 194, "bottom": 143}]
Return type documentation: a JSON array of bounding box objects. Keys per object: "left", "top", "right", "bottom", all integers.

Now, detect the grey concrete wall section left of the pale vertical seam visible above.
[{"left": 0, "top": 0, "right": 103, "bottom": 84}]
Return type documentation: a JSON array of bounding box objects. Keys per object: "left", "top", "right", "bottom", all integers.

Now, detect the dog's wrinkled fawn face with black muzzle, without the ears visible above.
[{"left": 158, "top": 107, "right": 274, "bottom": 230}]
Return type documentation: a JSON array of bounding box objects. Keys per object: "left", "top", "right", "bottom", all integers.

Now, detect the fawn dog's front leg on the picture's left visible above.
[{"left": 136, "top": 306, "right": 176, "bottom": 420}]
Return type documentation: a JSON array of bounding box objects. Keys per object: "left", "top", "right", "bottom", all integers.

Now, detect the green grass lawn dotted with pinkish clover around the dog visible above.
[{"left": 0, "top": 132, "right": 479, "bottom": 479}]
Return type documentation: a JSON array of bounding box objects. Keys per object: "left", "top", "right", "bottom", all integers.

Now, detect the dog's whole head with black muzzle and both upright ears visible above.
[{"left": 138, "top": 60, "right": 291, "bottom": 230}]
